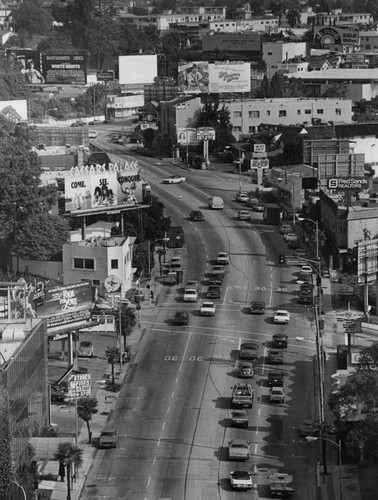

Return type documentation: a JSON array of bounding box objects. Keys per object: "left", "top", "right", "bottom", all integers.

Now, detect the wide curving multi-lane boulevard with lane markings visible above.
[{"left": 82, "top": 135, "right": 322, "bottom": 500}]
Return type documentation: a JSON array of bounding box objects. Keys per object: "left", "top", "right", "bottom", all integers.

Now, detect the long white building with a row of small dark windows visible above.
[{"left": 221, "top": 97, "right": 352, "bottom": 141}]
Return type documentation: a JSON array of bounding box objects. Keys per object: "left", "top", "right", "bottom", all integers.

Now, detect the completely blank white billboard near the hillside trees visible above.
[{"left": 118, "top": 54, "right": 157, "bottom": 85}]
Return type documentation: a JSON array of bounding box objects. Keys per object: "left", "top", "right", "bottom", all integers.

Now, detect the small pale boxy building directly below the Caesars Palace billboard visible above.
[{"left": 63, "top": 236, "right": 135, "bottom": 298}]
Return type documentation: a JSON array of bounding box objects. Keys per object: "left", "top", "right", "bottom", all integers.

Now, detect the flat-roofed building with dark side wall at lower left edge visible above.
[{"left": 0, "top": 306, "right": 50, "bottom": 470}]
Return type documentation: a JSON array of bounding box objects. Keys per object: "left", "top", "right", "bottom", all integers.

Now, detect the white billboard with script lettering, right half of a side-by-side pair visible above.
[{"left": 209, "top": 61, "right": 251, "bottom": 92}]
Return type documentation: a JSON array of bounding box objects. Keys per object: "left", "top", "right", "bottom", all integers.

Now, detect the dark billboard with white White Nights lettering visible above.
[{"left": 42, "top": 54, "right": 87, "bottom": 85}]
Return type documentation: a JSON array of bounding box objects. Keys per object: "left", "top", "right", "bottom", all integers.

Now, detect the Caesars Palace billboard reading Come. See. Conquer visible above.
[{"left": 64, "top": 161, "right": 144, "bottom": 212}]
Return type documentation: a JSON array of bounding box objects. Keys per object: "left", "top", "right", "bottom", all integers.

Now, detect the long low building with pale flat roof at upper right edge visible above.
[{"left": 289, "top": 68, "right": 378, "bottom": 102}]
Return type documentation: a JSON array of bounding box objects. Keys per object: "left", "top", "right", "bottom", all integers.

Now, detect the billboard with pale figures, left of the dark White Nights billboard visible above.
[{"left": 5, "top": 48, "right": 45, "bottom": 85}]
